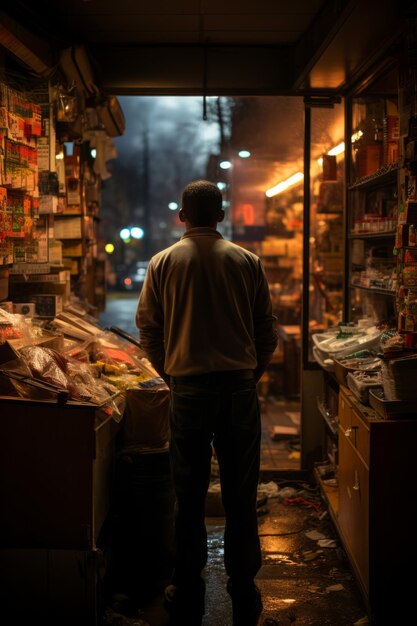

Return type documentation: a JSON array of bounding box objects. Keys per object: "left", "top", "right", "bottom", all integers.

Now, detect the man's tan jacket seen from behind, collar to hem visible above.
[{"left": 138, "top": 227, "right": 275, "bottom": 376}]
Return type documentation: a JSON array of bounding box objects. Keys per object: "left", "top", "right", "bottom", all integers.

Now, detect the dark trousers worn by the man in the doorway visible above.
[{"left": 170, "top": 371, "right": 261, "bottom": 587}]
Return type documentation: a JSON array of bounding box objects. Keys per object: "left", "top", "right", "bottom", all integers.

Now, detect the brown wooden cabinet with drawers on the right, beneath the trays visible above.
[{"left": 333, "top": 386, "right": 417, "bottom": 626}]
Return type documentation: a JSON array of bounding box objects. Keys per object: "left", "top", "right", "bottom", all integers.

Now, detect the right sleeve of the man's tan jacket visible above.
[{"left": 253, "top": 260, "right": 278, "bottom": 380}]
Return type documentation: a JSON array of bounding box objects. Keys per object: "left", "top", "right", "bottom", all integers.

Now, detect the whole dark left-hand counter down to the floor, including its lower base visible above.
[{"left": 0, "top": 396, "right": 119, "bottom": 626}]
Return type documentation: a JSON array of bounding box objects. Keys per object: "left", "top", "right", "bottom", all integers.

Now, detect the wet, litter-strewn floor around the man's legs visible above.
[{"left": 103, "top": 481, "right": 368, "bottom": 626}]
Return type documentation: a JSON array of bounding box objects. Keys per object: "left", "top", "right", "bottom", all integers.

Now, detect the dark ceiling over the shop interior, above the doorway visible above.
[{"left": 0, "top": 0, "right": 416, "bottom": 95}]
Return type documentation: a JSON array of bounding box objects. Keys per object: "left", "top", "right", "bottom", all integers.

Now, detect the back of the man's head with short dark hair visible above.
[{"left": 182, "top": 179, "right": 223, "bottom": 226}]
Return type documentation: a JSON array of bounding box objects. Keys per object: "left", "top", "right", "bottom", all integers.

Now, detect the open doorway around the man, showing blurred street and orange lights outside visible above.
[{"left": 101, "top": 96, "right": 304, "bottom": 470}]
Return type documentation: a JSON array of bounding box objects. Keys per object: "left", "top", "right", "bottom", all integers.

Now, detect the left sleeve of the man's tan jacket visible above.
[{"left": 136, "top": 260, "right": 169, "bottom": 382}]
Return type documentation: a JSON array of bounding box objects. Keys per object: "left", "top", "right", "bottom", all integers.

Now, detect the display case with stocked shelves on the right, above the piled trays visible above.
[{"left": 345, "top": 68, "right": 399, "bottom": 325}]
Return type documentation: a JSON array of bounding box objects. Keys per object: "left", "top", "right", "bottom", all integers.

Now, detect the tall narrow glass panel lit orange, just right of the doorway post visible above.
[{"left": 303, "top": 100, "right": 345, "bottom": 367}]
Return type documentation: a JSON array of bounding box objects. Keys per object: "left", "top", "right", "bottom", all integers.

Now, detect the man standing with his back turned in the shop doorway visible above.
[{"left": 136, "top": 180, "right": 277, "bottom": 626}]
